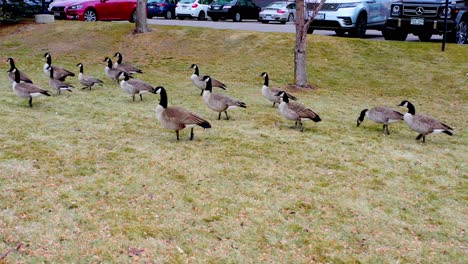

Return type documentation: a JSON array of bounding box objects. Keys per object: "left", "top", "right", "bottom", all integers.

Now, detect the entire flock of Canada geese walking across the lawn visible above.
[{"left": 7, "top": 52, "right": 453, "bottom": 142}]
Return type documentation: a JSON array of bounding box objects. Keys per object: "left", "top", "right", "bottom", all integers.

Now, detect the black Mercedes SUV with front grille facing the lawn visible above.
[{"left": 384, "top": 0, "right": 467, "bottom": 42}]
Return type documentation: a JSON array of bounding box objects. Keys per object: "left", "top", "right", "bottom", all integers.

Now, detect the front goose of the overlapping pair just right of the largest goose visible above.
[{"left": 202, "top": 76, "right": 247, "bottom": 120}]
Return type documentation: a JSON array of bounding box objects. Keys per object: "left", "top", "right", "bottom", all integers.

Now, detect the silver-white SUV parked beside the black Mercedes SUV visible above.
[{"left": 308, "top": 0, "right": 392, "bottom": 38}]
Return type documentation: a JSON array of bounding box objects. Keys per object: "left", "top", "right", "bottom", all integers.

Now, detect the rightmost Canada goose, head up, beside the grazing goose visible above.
[{"left": 398, "top": 100, "right": 453, "bottom": 143}]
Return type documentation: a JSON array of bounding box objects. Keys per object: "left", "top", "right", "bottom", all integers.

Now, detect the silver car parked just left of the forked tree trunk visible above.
[{"left": 258, "top": 1, "right": 296, "bottom": 24}]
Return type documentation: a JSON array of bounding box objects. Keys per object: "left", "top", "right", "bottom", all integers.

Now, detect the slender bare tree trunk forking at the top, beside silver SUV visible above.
[{"left": 294, "top": 0, "right": 326, "bottom": 88}]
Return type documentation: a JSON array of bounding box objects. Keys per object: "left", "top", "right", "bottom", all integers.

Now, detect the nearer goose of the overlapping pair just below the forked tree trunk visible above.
[{"left": 278, "top": 92, "right": 322, "bottom": 132}]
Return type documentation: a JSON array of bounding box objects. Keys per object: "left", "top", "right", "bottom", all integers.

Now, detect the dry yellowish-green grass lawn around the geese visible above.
[{"left": 0, "top": 21, "right": 468, "bottom": 263}]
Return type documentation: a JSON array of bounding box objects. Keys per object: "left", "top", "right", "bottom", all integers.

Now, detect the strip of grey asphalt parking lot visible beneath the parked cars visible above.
[{"left": 148, "top": 17, "right": 442, "bottom": 42}]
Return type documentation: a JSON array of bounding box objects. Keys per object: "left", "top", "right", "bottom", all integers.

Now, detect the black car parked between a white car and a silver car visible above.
[{"left": 208, "top": 0, "right": 260, "bottom": 22}]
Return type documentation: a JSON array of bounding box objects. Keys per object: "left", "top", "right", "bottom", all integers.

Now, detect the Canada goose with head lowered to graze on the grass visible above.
[{"left": 357, "top": 106, "right": 403, "bottom": 135}]
